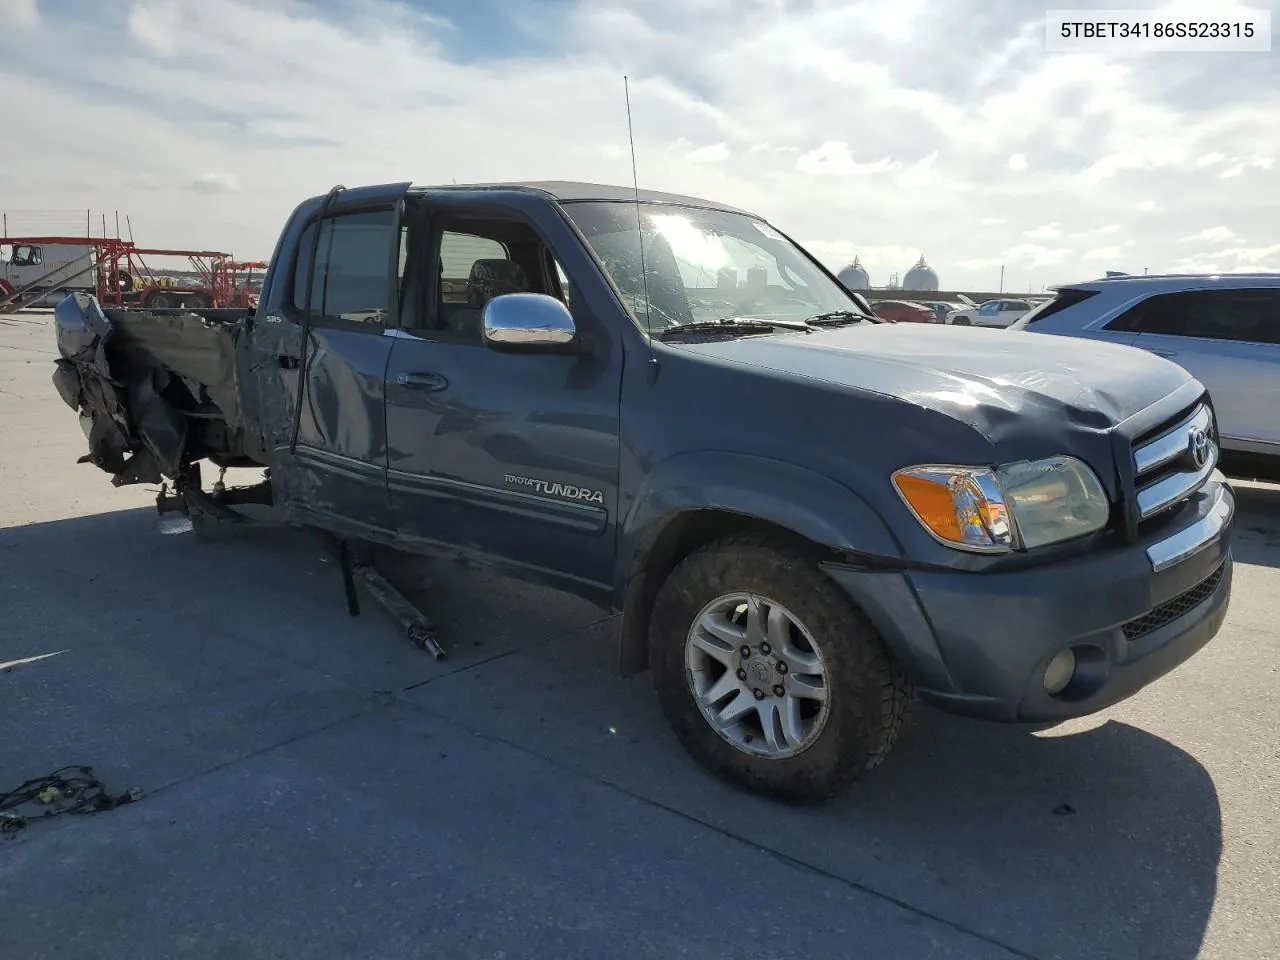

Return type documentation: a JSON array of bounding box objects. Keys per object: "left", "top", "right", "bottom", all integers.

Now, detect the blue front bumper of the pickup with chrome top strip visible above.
[{"left": 824, "top": 475, "right": 1235, "bottom": 721}]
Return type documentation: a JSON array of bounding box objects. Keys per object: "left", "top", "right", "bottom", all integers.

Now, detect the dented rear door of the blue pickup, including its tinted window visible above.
[{"left": 253, "top": 184, "right": 408, "bottom": 536}]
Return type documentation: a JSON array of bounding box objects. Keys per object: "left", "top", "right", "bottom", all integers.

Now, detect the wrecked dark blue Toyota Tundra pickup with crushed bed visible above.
[{"left": 55, "top": 183, "right": 1234, "bottom": 800}]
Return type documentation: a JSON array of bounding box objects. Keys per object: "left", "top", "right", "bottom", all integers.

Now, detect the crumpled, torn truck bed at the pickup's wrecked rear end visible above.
[{"left": 54, "top": 293, "right": 257, "bottom": 485}]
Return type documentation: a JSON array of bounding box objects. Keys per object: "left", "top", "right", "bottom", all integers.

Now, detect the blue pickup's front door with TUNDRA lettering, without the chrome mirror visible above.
[{"left": 387, "top": 199, "right": 622, "bottom": 585}]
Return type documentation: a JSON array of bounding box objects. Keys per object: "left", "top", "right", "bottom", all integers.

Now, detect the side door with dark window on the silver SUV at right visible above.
[{"left": 1107, "top": 288, "right": 1280, "bottom": 454}]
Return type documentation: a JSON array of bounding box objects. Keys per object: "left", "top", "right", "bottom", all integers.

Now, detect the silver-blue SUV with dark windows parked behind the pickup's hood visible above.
[{"left": 1011, "top": 274, "right": 1280, "bottom": 476}]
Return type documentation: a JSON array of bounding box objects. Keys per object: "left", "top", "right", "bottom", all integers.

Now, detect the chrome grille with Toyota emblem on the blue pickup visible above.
[{"left": 1133, "top": 402, "right": 1219, "bottom": 524}]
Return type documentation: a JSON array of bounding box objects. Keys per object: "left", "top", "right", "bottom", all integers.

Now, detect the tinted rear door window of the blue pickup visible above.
[{"left": 293, "top": 209, "right": 406, "bottom": 326}]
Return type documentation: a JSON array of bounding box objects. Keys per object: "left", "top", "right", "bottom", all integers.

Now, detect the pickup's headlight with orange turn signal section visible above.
[{"left": 893, "top": 457, "right": 1111, "bottom": 553}]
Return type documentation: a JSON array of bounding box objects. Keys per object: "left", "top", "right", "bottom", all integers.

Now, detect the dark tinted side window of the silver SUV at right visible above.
[{"left": 1107, "top": 289, "right": 1280, "bottom": 343}]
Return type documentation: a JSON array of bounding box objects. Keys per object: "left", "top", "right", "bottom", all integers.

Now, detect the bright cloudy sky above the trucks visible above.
[{"left": 0, "top": 0, "right": 1280, "bottom": 292}]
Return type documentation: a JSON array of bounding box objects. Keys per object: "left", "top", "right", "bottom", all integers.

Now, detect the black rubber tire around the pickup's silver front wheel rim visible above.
[{"left": 649, "top": 535, "right": 911, "bottom": 803}]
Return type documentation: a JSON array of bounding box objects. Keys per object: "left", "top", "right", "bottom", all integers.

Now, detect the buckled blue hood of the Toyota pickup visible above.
[{"left": 682, "top": 324, "right": 1192, "bottom": 440}]
